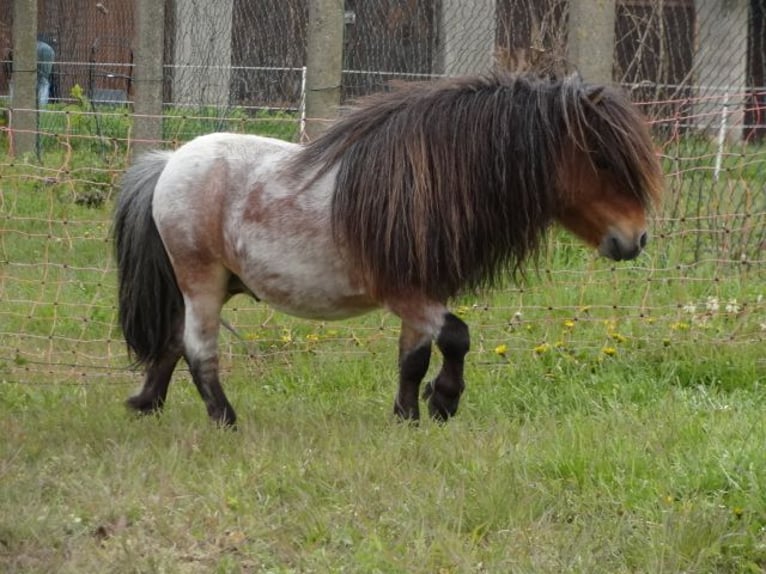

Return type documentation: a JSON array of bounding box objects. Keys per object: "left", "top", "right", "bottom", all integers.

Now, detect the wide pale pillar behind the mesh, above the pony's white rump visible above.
[{"left": 173, "top": 0, "right": 234, "bottom": 108}]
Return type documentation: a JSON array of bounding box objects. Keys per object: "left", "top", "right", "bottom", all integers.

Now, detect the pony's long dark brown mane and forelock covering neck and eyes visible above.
[{"left": 293, "top": 74, "right": 660, "bottom": 300}]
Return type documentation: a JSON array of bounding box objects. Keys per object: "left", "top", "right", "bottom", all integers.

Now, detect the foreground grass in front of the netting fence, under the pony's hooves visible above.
[{"left": 0, "top": 357, "right": 766, "bottom": 572}]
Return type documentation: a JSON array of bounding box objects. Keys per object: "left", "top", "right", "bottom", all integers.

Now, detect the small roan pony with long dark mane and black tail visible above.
[{"left": 113, "top": 73, "right": 662, "bottom": 426}]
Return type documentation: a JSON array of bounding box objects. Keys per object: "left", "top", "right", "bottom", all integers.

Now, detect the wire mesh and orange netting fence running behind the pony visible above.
[{"left": 0, "top": 0, "right": 766, "bottom": 383}]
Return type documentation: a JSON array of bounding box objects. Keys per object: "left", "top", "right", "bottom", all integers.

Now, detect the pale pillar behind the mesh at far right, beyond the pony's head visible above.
[{"left": 694, "top": 0, "right": 748, "bottom": 141}]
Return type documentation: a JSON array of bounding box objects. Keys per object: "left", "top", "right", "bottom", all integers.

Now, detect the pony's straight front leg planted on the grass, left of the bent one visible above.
[{"left": 394, "top": 321, "right": 431, "bottom": 421}]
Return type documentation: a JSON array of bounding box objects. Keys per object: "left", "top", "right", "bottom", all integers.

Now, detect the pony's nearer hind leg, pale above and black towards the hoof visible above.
[{"left": 183, "top": 295, "right": 237, "bottom": 427}]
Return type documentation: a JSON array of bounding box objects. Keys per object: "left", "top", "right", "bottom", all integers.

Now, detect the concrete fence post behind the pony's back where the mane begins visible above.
[{"left": 303, "top": 0, "right": 343, "bottom": 141}]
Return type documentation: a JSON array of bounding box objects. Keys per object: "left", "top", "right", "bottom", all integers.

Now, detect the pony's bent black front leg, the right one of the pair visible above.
[{"left": 423, "top": 313, "right": 471, "bottom": 421}]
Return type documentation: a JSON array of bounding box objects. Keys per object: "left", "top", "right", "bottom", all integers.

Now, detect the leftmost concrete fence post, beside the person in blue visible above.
[{"left": 10, "top": 0, "right": 37, "bottom": 154}]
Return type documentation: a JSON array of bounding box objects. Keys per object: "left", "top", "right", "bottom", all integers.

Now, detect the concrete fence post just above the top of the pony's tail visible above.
[{"left": 132, "top": 0, "right": 165, "bottom": 152}]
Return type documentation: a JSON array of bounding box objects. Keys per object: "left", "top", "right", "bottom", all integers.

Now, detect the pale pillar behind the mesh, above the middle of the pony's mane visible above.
[{"left": 434, "top": 0, "right": 497, "bottom": 76}]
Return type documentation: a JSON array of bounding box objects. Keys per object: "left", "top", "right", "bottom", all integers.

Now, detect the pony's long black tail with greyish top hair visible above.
[{"left": 114, "top": 152, "right": 184, "bottom": 365}]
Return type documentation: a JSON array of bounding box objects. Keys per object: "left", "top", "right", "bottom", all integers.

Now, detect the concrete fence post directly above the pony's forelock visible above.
[{"left": 567, "top": 0, "right": 616, "bottom": 84}]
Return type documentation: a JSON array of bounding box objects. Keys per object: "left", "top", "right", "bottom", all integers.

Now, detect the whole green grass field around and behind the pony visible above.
[{"left": 0, "top": 119, "right": 766, "bottom": 573}]
